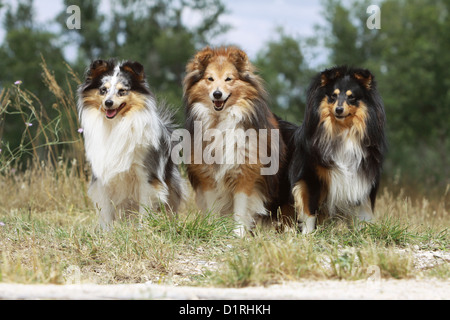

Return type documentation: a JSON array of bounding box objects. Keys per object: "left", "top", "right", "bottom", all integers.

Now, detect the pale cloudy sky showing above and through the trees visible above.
[{"left": 0, "top": 0, "right": 323, "bottom": 64}]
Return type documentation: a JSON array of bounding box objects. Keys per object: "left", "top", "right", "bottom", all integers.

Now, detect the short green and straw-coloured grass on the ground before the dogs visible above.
[{"left": 0, "top": 168, "right": 450, "bottom": 287}]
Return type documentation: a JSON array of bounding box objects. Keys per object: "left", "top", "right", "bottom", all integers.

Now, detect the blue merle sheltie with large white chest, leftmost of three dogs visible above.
[{"left": 78, "top": 60, "right": 185, "bottom": 229}]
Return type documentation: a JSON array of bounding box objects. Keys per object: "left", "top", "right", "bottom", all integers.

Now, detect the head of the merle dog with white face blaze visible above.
[{"left": 79, "top": 60, "right": 150, "bottom": 120}]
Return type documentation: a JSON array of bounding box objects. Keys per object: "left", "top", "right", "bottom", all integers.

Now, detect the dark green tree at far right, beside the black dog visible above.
[{"left": 377, "top": 0, "right": 450, "bottom": 184}]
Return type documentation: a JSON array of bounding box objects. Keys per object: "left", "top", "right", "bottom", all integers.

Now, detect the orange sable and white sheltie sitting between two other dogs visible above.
[{"left": 184, "top": 47, "right": 285, "bottom": 236}]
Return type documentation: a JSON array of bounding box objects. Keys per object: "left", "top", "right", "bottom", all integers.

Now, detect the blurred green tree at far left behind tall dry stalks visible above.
[{"left": 0, "top": 0, "right": 65, "bottom": 156}]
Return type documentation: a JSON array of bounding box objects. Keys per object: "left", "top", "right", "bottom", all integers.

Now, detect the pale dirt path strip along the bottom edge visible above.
[{"left": 0, "top": 280, "right": 450, "bottom": 300}]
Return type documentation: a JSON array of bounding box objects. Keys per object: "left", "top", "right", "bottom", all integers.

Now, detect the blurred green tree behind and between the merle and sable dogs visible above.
[{"left": 59, "top": 0, "right": 227, "bottom": 120}]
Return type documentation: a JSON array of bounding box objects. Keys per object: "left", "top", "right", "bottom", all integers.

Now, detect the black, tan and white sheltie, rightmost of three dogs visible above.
[{"left": 289, "top": 66, "right": 386, "bottom": 233}]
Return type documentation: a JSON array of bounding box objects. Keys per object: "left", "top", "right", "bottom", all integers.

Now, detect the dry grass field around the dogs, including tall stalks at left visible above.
[{"left": 0, "top": 64, "right": 450, "bottom": 287}]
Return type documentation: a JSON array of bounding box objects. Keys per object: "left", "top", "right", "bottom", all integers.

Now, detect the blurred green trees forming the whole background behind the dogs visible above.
[{"left": 0, "top": 0, "right": 450, "bottom": 191}]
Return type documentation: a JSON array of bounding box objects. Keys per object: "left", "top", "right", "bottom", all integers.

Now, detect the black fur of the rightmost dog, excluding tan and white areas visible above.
[{"left": 280, "top": 66, "right": 387, "bottom": 224}]
